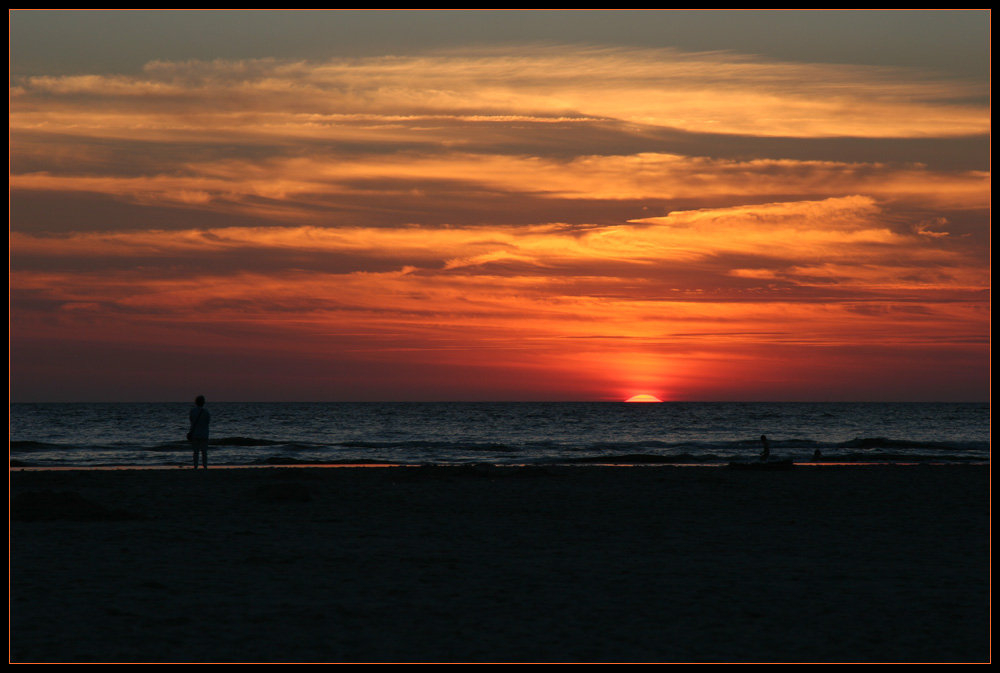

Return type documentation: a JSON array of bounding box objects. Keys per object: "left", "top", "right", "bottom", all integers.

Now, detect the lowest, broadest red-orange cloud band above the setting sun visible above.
[{"left": 11, "top": 197, "right": 989, "bottom": 360}]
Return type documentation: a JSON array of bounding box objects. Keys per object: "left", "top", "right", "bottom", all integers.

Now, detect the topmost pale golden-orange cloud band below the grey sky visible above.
[{"left": 12, "top": 47, "right": 990, "bottom": 137}]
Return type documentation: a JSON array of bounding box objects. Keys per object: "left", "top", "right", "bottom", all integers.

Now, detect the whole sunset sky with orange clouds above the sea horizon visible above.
[{"left": 9, "top": 10, "right": 991, "bottom": 402}]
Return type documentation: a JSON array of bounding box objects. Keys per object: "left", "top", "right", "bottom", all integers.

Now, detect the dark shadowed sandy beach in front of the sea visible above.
[{"left": 10, "top": 466, "right": 990, "bottom": 662}]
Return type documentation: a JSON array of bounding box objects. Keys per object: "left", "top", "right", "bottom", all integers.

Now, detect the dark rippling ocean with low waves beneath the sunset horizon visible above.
[{"left": 10, "top": 402, "right": 990, "bottom": 468}]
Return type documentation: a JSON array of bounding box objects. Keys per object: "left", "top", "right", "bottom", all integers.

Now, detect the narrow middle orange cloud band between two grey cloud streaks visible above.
[{"left": 11, "top": 154, "right": 991, "bottom": 224}]
